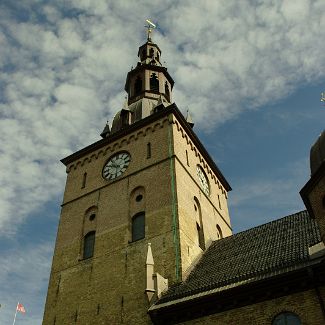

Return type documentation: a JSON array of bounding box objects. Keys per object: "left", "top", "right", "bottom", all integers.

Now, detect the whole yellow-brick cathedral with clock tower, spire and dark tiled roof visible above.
[{"left": 43, "top": 29, "right": 325, "bottom": 325}]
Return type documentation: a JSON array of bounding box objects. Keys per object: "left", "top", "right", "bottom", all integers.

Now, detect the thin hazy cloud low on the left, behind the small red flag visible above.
[{"left": 0, "top": 243, "right": 53, "bottom": 325}]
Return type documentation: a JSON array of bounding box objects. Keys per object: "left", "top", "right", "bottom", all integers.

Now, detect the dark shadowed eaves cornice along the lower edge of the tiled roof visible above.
[{"left": 148, "top": 260, "right": 325, "bottom": 324}]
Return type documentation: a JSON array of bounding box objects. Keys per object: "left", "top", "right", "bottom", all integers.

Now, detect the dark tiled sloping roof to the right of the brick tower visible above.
[{"left": 156, "top": 211, "right": 321, "bottom": 305}]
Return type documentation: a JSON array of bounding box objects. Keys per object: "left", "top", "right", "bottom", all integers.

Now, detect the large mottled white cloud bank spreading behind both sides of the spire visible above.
[{"left": 0, "top": 0, "right": 325, "bottom": 234}]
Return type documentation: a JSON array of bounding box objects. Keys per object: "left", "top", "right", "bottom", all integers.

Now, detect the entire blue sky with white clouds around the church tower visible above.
[{"left": 0, "top": 0, "right": 325, "bottom": 325}]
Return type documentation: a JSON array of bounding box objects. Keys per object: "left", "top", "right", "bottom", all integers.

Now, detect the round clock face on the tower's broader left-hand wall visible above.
[{"left": 103, "top": 152, "right": 131, "bottom": 180}]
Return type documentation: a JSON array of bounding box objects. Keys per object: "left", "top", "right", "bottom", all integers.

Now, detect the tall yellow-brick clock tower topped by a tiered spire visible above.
[{"left": 43, "top": 29, "right": 232, "bottom": 325}]
